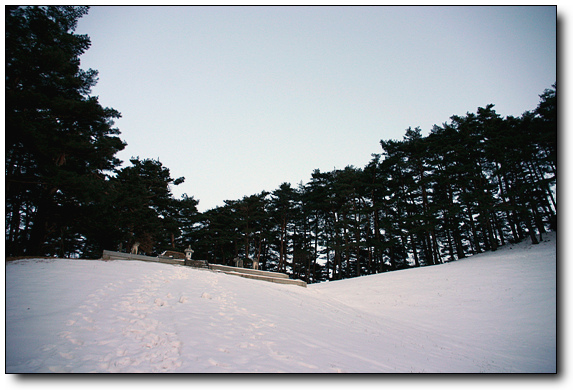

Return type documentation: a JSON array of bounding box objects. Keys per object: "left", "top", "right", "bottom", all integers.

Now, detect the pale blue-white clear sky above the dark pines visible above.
[{"left": 76, "top": 6, "right": 557, "bottom": 211}]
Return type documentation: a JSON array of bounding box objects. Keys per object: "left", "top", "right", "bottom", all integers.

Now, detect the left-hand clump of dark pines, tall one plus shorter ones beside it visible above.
[{"left": 5, "top": 6, "right": 197, "bottom": 257}]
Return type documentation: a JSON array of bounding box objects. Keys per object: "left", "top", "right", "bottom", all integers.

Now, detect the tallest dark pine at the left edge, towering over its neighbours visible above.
[{"left": 5, "top": 6, "right": 125, "bottom": 255}]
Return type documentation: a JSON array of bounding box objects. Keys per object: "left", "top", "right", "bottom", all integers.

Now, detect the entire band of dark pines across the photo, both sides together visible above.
[{"left": 5, "top": 7, "right": 557, "bottom": 283}]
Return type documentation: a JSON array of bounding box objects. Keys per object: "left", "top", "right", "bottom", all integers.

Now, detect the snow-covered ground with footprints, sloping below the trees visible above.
[{"left": 6, "top": 235, "right": 557, "bottom": 373}]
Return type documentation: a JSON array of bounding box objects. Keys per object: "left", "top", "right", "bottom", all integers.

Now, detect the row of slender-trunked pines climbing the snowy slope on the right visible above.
[{"left": 190, "top": 85, "right": 557, "bottom": 282}]
